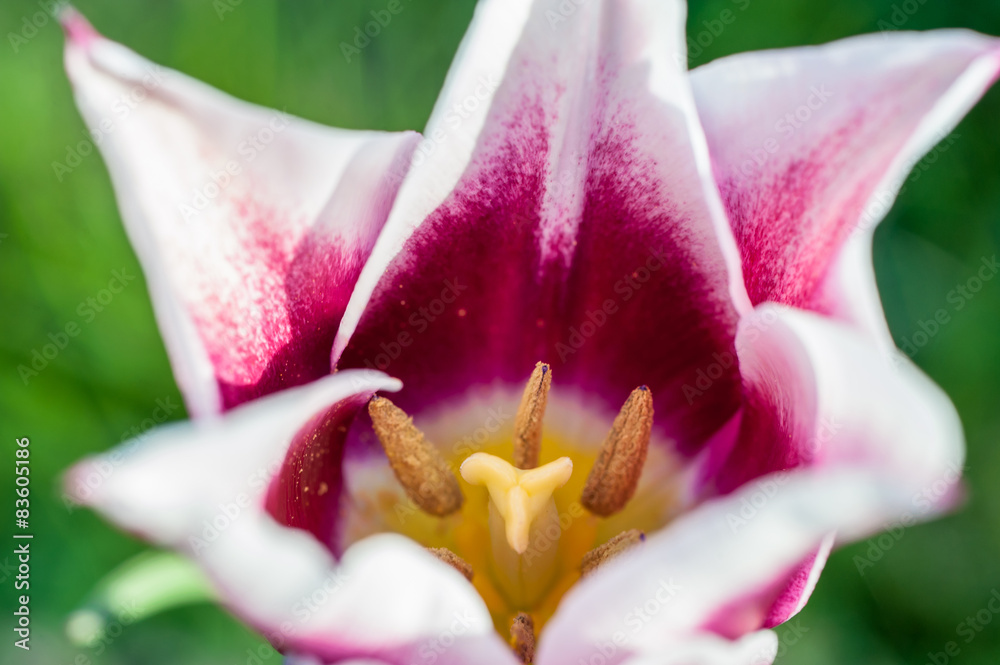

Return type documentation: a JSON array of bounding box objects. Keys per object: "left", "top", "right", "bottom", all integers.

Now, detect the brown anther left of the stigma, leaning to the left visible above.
[{"left": 368, "top": 397, "right": 463, "bottom": 517}]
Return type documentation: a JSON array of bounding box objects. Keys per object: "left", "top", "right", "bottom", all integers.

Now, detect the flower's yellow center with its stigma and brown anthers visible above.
[{"left": 354, "top": 363, "right": 677, "bottom": 662}]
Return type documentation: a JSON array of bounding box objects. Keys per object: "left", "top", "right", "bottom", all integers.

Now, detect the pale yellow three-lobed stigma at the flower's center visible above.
[{"left": 461, "top": 453, "right": 573, "bottom": 554}]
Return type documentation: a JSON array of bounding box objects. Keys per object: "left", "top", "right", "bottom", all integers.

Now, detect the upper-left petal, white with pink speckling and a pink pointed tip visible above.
[{"left": 61, "top": 9, "right": 419, "bottom": 416}]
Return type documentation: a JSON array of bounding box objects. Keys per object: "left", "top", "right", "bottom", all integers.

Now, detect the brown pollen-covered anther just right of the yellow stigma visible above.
[{"left": 580, "top": 386, "right": 653, "bottom": 517}]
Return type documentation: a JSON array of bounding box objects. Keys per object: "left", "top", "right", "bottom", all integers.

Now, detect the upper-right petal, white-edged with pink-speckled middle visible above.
[{"left": 691, "top": 30, "right": 1000, "bottom": 346}]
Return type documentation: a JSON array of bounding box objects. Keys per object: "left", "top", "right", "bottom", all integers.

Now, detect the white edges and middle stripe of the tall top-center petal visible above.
[{"left": 334, "top": 0, "right": 751, "bottom": 366}]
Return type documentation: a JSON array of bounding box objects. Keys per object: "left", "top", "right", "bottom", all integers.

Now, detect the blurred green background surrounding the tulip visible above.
[{"left": 0, "top": 0, "right": 1000, "bottom": 665}]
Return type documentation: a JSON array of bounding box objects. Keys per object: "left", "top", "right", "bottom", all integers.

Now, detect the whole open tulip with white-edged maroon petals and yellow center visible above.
[{"left": 63, "top": 0, "right": 1000, "bottom": 665}]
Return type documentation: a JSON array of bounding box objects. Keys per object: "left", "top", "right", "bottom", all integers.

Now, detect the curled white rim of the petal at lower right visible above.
[{"left": 539, "top": 305, "right": 964, "bottom": 665}]
